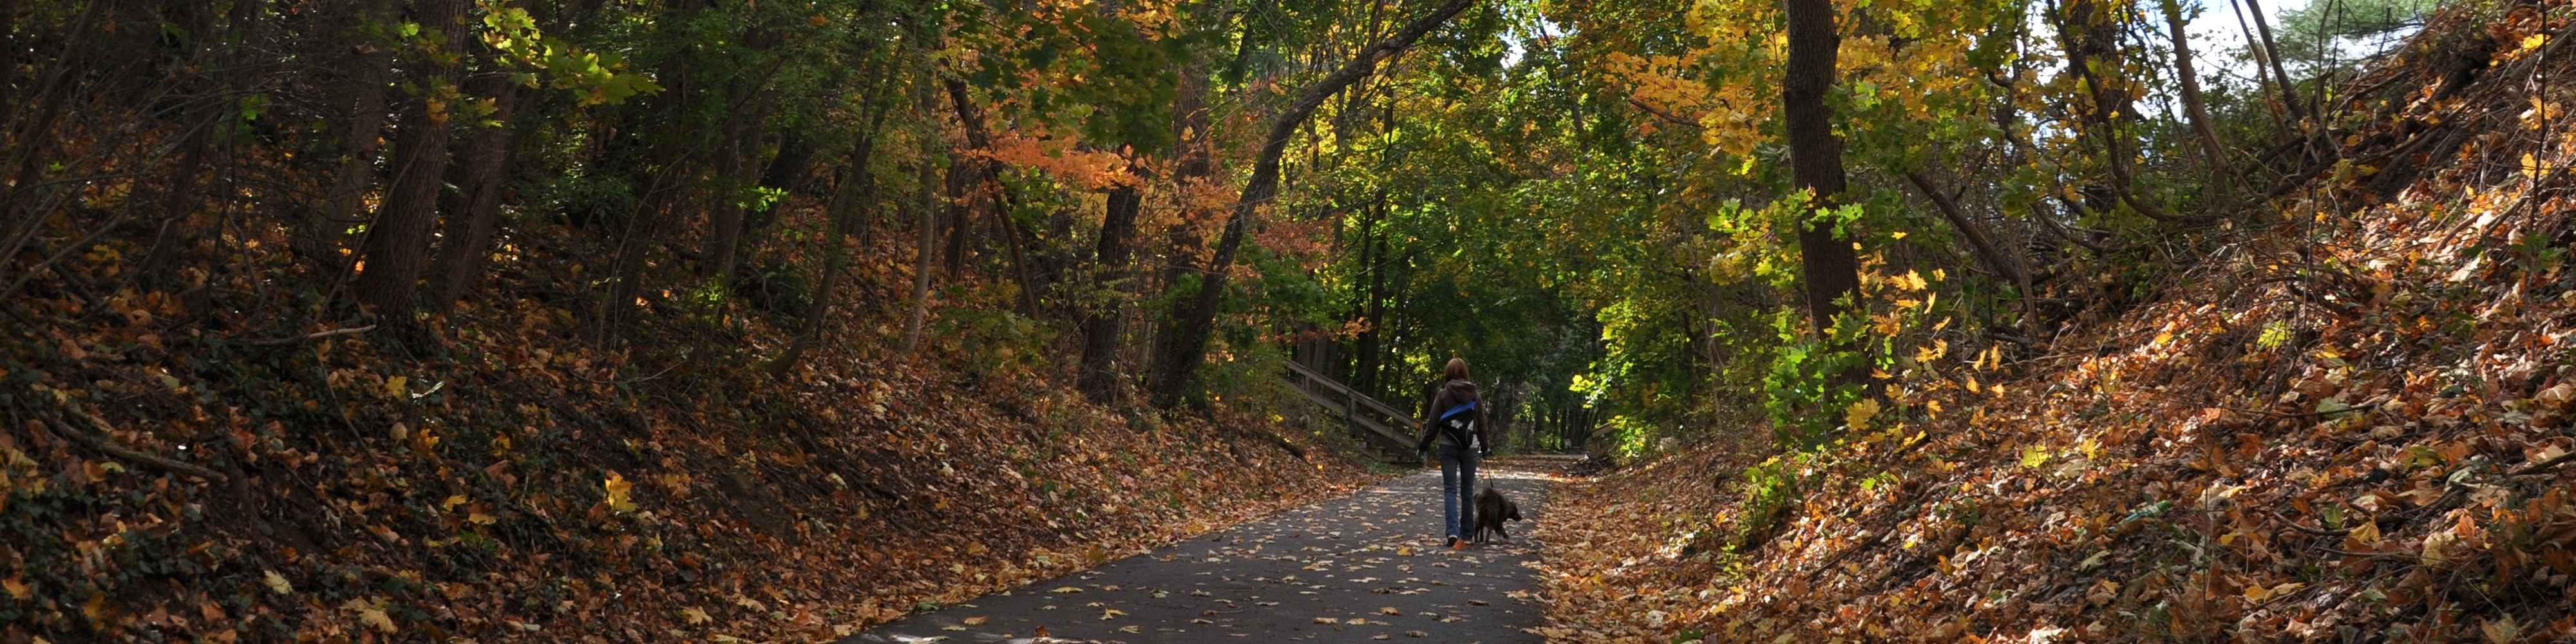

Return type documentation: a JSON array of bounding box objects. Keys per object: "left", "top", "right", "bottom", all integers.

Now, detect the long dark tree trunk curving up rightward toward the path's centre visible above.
[{"left": 1151, "top": 0, "right": 1473, "bottom": 407}]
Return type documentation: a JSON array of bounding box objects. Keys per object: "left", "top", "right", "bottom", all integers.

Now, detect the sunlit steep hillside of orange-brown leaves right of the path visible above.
[{"left": 1546, "top": 3, "right": 2576, "bottom": 641}]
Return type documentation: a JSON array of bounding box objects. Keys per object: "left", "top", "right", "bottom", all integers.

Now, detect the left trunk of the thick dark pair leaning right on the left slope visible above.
[{"left": 358, "top": 0, "right": 471, "bottom": 314}]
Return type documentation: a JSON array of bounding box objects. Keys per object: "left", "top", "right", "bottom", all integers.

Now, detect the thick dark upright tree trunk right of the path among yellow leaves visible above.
[{"left": 1780, "top": 0, "right": 1860, "bottom": 343}]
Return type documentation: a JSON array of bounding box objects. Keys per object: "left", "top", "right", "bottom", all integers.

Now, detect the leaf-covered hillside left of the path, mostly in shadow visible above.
[{"left": 0, "top": 204, "right": 1370, "bottom": 641}]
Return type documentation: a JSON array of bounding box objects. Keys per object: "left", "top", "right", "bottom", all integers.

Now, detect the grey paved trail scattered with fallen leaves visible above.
[{"left": 845, "top": 466, "right": 1546, "bottom": 644}]
